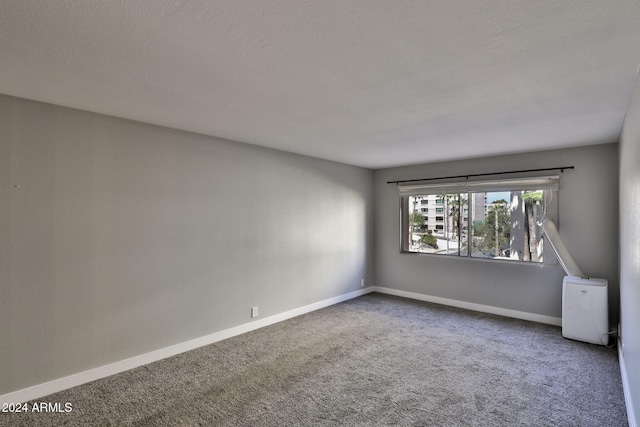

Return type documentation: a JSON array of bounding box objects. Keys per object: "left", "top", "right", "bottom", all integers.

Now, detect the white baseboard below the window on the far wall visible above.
[{"left": 372, "top": 286, "right": 562, "bottom": 326}]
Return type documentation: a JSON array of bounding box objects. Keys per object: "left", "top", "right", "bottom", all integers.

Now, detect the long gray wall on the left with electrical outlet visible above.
[{"left": 0, "top": 96, "right": 373, "bottom": 395}]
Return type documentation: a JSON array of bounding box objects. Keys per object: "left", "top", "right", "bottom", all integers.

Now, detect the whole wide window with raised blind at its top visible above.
[{"left": 398, "top": 177, "right": 558, "bottom": 262}]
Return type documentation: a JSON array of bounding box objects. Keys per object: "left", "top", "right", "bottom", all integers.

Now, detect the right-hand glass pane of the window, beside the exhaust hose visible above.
[{"left": 471, "top": 190, "right": 545, "bottom": 262}]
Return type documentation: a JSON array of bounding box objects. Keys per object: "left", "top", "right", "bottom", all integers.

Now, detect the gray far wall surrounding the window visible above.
[{"left": 374, "top": 144, "right": 619, "bottom": 324}]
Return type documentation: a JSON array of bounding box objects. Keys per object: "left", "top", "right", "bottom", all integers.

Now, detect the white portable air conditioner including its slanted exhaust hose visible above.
[{"left": 543, "top": 220, "right": 609, "bottom": 345}]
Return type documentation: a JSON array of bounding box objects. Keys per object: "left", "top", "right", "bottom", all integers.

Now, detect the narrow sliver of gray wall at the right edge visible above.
[{"left": 620, "top": 75, "right": 640, "bottom": 420}]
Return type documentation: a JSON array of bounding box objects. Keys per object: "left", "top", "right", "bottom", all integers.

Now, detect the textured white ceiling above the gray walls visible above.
[{"left": 0, "top": 0, "right": 640, "bottom": 168}]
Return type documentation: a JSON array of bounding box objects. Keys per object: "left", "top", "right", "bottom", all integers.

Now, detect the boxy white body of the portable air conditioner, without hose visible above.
[{"left": 562, "top": 276, "right": 609, "bottom": 345}]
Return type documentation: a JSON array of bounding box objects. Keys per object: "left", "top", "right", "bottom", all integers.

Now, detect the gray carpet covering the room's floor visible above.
[{"left": 0, "top": 293, "right": 627, "bottom": 427}]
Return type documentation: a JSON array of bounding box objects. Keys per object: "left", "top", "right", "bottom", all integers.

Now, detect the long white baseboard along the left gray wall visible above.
[{"left": 0, "top": 287, "right": 373, "bottom": 404}]
